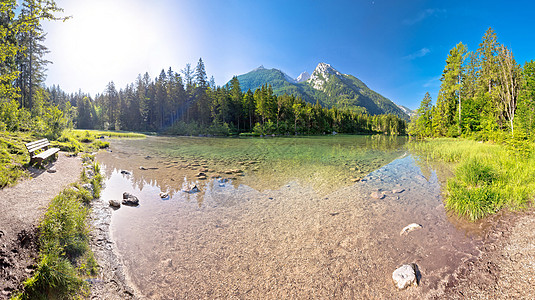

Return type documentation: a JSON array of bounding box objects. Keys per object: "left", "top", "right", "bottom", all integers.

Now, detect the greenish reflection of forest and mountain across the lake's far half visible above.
[{"left": 98, "top": 135, "right": 405, "bottom": 201}]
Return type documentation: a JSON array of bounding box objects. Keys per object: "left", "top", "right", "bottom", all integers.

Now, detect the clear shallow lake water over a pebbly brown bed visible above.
[{"left": 98, "top": 136, "right": 494, "bottom": 299}]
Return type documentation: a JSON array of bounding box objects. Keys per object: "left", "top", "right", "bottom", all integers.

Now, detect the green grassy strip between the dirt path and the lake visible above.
[{"left": 13, "top": 155, "right": 102, "bottom": 299}]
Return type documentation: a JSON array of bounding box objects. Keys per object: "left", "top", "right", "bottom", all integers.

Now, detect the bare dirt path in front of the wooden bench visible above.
[{"left": 0, "top": 152, "right": 82, "bottom": 299}]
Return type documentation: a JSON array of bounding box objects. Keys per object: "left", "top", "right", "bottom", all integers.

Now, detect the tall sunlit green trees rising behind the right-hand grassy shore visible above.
[{"left": 409, "top": 28, "right": 535, "bottom": 140}]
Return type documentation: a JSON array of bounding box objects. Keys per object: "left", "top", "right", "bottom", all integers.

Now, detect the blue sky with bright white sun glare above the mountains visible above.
[{"left": 45, "top": 0, "right": 535, "bottom": 109}]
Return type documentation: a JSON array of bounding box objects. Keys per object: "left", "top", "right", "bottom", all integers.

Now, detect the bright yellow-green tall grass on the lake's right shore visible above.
[{"left": 409, "top": 138, "right": 535, "bottom": 220}]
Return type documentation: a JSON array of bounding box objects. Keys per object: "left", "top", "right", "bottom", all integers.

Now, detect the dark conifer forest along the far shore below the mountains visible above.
[{"left": 65, "top": 59, "right": 406, "bottom": 135}]
